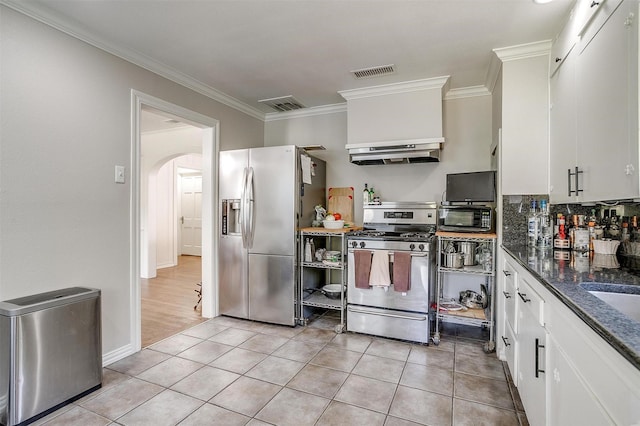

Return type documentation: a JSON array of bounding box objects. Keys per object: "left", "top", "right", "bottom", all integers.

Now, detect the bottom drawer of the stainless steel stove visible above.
[{"left": 347, "top": 305, "right": 431, "bottom": 343}]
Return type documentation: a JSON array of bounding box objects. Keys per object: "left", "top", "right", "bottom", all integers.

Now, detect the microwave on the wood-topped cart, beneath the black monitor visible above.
[{"left": 438, "top": 206, "right": 495, "bottom": 232}]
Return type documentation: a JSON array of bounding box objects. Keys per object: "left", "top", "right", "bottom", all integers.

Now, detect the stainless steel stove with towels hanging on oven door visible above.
[{"left": 347, "top": 202, "right": 437, "bottom": 343}]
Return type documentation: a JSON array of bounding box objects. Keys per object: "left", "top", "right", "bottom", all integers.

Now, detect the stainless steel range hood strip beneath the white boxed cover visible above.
[{"left": 345, "top": 138, "right": 444, "bottom": 166}]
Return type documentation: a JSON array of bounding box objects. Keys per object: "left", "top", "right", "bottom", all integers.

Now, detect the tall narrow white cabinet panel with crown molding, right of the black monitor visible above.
[{"left": 495, "top": 42, "right": 551, "bottom": 194}]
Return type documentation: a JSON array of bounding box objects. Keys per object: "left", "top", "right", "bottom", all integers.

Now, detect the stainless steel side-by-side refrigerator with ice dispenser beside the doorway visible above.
[{"left": 218, "top": 145, "right": 326, "bottom": 325}]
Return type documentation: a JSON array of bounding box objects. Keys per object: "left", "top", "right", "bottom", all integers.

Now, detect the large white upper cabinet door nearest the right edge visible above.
[{"left": 576, "top": 2, "right": 638, "bottom": 201}]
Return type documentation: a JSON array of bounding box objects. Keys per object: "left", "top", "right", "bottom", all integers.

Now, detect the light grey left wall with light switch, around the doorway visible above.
[{"left": 0, "top": 6, "right": 264, "bottom": 354}]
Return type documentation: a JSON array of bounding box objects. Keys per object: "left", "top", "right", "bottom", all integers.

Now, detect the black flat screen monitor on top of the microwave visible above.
[{"left": 446, "top": 170, "right": 496, "bottom": 204}]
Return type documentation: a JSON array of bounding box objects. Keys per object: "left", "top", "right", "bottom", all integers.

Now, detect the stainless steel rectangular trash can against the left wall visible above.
[{"left": 0, "top": 287, "right": 102, "bottom": 426}]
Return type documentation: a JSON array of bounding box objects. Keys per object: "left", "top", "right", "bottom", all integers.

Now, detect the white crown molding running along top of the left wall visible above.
[{"left": 0, "top": 0, "right": 265, "bottom": 121}]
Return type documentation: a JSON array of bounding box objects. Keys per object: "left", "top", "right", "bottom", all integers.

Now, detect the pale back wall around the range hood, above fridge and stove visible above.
[{"left": 265, "top": 96, "right": 492, "bottom": 224}]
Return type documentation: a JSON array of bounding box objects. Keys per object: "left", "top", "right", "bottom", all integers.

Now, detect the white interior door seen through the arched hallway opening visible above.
[{"left": 180, "top": 175, "right": 202, "bottom": 256}]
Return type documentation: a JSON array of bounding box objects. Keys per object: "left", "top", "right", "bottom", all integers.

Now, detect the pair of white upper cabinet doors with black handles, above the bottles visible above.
[{"left": 549, "top": 0, "right": 640, "bottom": 203}]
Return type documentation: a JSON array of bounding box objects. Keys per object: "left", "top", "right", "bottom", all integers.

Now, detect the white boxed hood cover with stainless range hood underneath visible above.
[{"left": 338, "top": 76, "right": 449, "bottom": 166}]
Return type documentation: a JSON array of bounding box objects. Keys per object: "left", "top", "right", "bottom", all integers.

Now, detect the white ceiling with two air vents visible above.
[{"left": 5, "top": 0, "right": 574, "bottom": 115}]
